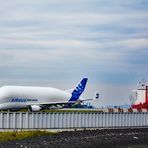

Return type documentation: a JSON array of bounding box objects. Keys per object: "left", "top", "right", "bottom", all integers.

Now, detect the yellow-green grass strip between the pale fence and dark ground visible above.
[{"left": 0, "top": 131, "right": 57, "bottom": 141}]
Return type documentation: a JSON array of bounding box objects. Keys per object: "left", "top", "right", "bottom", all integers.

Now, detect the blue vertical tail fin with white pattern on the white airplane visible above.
[{"left": 69, "top": 78, "right": 88, "bottom": 101}]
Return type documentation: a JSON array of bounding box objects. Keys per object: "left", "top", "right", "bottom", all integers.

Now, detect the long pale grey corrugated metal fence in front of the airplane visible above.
[{"left": 0, "top": 112, "right": 148, "bottom": 129}]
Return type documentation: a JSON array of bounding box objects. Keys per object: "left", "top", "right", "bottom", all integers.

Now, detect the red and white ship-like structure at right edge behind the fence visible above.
[{"left": 132, "top": 81, "right": 148, "bottom": 109}]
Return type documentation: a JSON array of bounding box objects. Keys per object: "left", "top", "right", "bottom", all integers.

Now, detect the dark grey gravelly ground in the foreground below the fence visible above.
[{"left": 0, "top": 128, "right": 148, "bottom": 148}]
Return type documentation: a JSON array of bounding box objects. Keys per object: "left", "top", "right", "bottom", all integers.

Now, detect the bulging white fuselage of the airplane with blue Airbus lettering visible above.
[{"left": 0, "top": 86, "right": 71, "bottom": 110}]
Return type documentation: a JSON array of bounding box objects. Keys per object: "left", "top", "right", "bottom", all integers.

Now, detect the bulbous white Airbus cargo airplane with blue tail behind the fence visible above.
[{"left": 0, "top": 78, "right": 97, "bottom": 111}]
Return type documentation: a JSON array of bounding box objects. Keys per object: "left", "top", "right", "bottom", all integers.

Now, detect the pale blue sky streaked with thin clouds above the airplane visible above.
[{"left": 0, "top": 0, "right": 148, "bottom": 105}]
